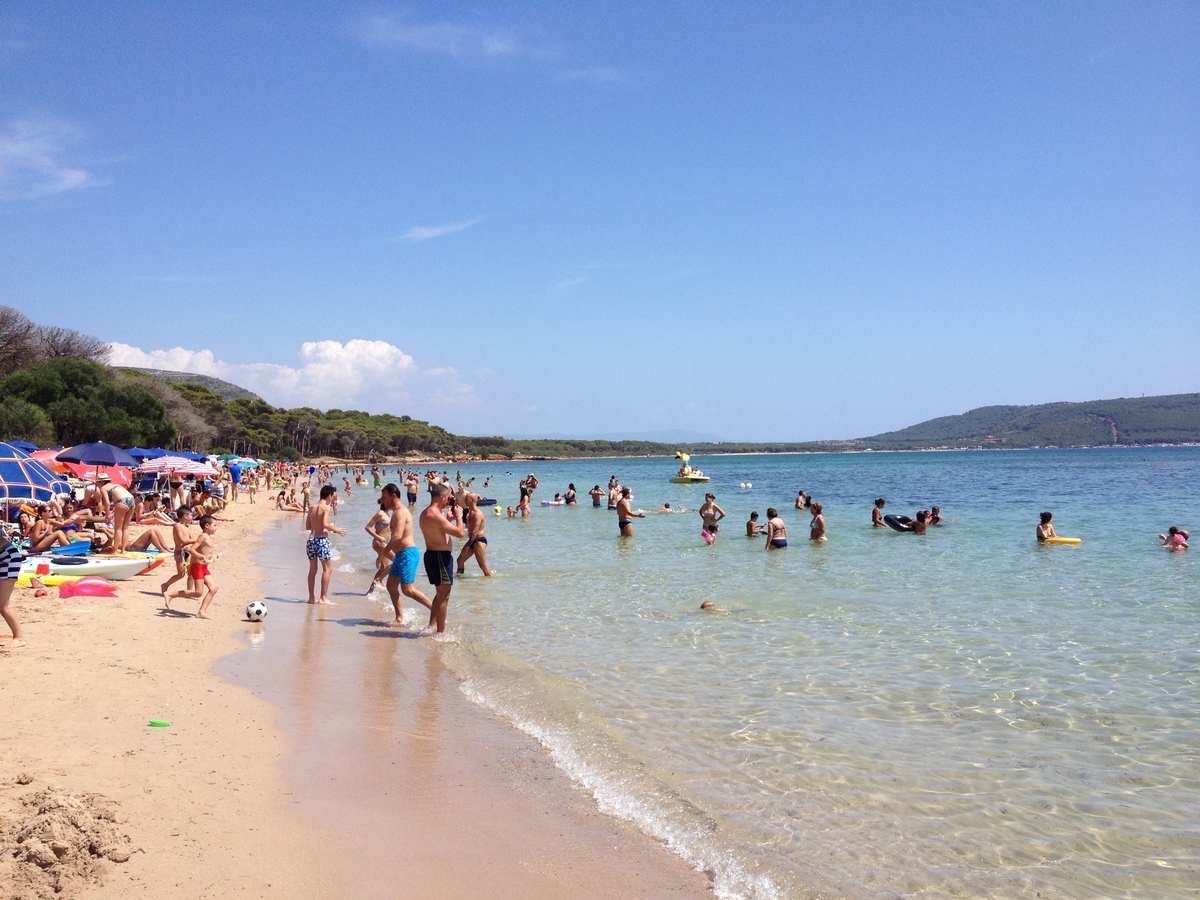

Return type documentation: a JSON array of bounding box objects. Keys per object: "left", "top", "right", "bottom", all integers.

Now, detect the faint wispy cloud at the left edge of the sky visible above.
[{"left": 0, "top": 118, "right": 107, "bottom": 200}]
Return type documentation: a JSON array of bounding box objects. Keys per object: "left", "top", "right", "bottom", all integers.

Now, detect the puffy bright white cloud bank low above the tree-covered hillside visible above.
[{"left": 109, "top": 338, "right": 478, "bottom": 416}]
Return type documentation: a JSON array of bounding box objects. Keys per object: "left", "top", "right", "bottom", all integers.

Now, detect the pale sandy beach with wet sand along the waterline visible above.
[{"left": 0, "top": 499, "right": 710, "bottom": 899}]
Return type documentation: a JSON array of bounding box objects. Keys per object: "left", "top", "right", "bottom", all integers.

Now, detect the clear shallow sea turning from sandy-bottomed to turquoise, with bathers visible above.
[{"left": 324, "top": 448, "right": 1200, "bottom": 898}]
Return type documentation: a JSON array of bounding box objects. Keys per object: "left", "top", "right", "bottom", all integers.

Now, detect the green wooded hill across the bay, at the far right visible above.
[{"left": 853, "top": 394, "right": 1200, "bottom": 450}]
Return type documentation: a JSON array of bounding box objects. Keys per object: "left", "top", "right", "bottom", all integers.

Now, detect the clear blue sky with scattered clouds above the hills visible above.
[{"left": 0, "top": 2, "right": 1200, "bottom": 440}]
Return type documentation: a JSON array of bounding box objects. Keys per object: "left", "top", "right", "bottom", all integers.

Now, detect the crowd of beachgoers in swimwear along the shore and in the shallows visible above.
[{"left": 0, "top": 462, "right": 1190, "bottom": 649}]
